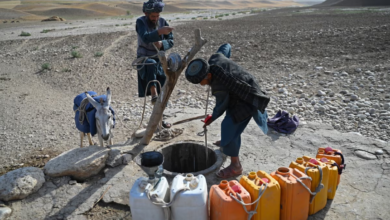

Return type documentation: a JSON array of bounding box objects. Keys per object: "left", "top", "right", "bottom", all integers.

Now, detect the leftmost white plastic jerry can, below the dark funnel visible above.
[{"left": 129, "top": 177, "right": 169, "bottom": 220}]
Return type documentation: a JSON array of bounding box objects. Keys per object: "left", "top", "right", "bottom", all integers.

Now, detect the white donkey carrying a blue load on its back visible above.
[{"left": 73, "top": 88, "right": 115, "bottom": 147}]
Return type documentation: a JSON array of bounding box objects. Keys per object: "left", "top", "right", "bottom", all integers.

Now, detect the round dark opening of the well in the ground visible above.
[{"left": 160, "top": 142, "right": 224, "bottom": 176}]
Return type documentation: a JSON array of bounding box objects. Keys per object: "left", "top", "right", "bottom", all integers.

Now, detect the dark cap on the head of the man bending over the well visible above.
[{"left": 186, "top": 58, "right": 210, "bottom": 84}]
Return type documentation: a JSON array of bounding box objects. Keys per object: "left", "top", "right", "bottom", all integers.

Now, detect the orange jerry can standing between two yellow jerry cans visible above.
[{"left": 271, "top": 167, "right": 311, "bottom": 220}]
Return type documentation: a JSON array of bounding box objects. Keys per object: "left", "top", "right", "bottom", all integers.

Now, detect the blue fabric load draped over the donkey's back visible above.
[{"left": 73, "top": 91, "right": 115, "bottom": 136}]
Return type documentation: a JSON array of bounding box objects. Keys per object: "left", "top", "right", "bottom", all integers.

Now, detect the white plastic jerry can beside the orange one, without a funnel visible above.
[{"left": 171, "top": 174, "right": 208, "bottom": 220}]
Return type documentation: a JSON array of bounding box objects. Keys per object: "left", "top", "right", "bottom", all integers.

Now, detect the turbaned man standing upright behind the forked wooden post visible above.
[{"left": 135, "top": 0, "right": 173, "bottom": 128}]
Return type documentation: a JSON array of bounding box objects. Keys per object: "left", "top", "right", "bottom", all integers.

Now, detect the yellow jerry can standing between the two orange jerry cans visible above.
[{"left": 240, "top": 170, "right": 281, "bottom": 220}]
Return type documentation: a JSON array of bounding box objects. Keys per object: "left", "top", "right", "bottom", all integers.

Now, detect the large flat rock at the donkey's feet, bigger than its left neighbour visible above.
[{"left": 44, "top": 146, "right": 110, "bottom": 180}]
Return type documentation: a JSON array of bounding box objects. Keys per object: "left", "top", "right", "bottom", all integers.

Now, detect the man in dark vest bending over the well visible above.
[{"left": 186, "top": 44, "right": 270, "bottom": 179}]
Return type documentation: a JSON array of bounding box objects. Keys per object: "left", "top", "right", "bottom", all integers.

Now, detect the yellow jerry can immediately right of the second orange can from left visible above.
[{"left": 290, "top": 156, "right": 329, "bottom": 215}]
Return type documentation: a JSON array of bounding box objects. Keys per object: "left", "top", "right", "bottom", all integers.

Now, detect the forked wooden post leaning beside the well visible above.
[{"left": 141, "top": 29, "right": 207, "bottom": 144}]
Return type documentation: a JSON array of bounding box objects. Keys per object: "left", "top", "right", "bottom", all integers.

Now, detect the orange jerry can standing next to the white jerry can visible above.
[{"left": 210, "top": 180, "right": 251, "bottom": 220}]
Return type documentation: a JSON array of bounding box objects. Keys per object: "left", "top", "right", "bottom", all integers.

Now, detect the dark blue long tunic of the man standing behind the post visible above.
[{"left": 136, "top": 16, "right": 174, "bottom": 97}]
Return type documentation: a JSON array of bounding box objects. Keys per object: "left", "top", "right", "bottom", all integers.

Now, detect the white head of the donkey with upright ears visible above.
[{"left": 85, "top": 87, "right": 114, "bottom": 140}]
